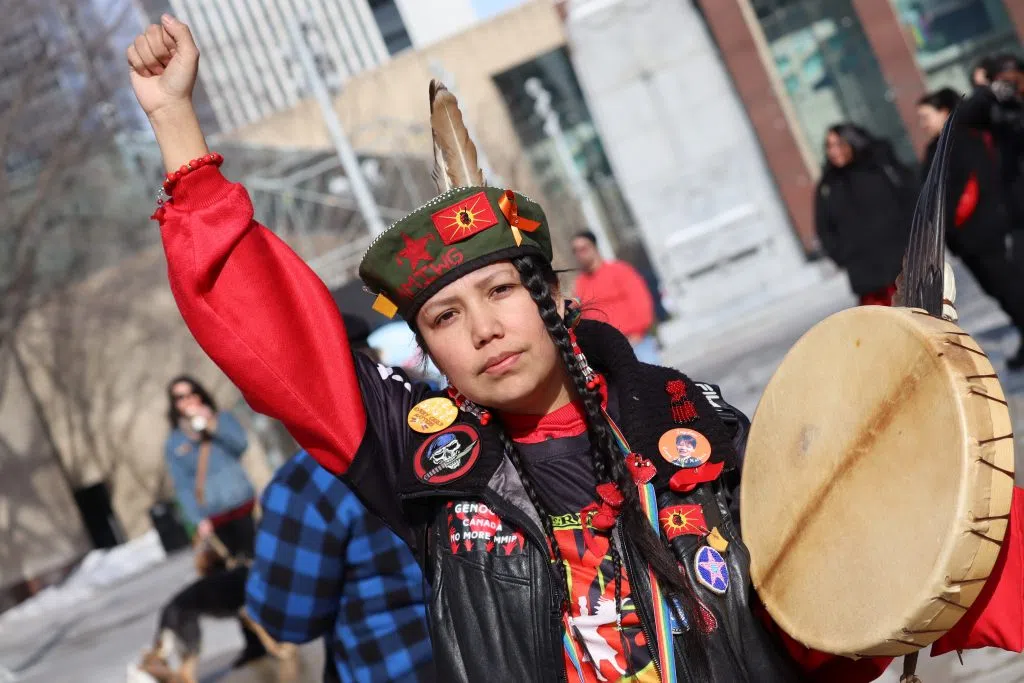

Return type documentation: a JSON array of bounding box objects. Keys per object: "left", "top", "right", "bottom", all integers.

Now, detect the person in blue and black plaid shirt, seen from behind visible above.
[{"left": 246, "top": 451, "right": 433, "bottom": 682}]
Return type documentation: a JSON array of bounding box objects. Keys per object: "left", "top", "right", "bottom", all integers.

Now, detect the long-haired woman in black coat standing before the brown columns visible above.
[{"left": 814, "top": 123, "right": 918, "bottom": 306}]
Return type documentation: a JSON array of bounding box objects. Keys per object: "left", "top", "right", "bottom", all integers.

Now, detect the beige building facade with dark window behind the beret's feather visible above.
[{"left": 225, "top": 0, "right": 593, "bottom": 272}]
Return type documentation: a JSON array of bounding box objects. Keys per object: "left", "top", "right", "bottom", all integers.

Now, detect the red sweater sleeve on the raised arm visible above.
[{"left": 154, "top": 166, "right": 367, "bottom": 473}]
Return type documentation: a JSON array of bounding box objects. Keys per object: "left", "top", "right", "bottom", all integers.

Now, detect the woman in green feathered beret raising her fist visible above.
[{"left": 128, "top": 16, "right": 1024, "bottom": 683}]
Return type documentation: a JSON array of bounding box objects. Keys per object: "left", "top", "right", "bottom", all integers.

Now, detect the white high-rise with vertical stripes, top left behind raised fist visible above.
[{"left": 161, "top": 0, "right": 475, "bottom": 131}]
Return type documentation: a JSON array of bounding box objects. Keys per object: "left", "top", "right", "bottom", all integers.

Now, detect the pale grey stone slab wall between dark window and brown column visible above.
[{"left": 566, "top": 0, "right": 823, "bottom": 337}]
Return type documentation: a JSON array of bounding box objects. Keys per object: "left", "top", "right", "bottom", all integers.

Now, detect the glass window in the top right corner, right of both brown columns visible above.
[{"left": 892, "top": 0, "right": 1021, "bottom": 92}]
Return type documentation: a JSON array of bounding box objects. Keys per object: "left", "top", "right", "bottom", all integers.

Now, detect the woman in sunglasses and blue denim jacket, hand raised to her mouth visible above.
[{"left": 164, "top": 375, "right": 266, "bottom": 668}]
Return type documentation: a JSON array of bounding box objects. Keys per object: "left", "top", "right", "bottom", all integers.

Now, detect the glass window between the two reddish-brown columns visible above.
[{"left": 751, "top": 0, "right": 915, "bottom": 162}]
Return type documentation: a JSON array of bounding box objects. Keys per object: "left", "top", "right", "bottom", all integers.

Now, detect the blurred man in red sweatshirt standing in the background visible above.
[{"left": 572, "top": 230, "right": 660, "bottom": 365}]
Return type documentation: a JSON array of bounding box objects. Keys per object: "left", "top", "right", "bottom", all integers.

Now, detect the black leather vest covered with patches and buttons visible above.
[{"left": 348, "top": 322, "right": 800, "bottom": 683}]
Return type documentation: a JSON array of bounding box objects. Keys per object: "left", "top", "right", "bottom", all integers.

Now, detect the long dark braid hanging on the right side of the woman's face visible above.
[{"left": 512, "top": 256, "right": 710, "bottom": 681}]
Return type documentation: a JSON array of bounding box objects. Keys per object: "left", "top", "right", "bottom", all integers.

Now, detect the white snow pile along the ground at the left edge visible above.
[{"left": 0, "top": 529, "right": 167, "bottom": 630}]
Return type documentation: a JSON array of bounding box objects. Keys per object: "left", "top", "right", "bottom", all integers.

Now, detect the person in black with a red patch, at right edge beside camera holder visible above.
[{"left": 918, "top": 88, "right": 1024, "bottom": 370}]
